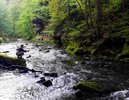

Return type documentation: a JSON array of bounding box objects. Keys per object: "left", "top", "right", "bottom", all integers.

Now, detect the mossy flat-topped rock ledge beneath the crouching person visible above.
[{"left": 0, "top": 55, "right": 26, "bottom": 66}]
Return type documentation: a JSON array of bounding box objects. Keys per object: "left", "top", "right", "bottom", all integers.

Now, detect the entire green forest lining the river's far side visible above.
[{"left": 0, "top": 0, "right": 129, "bottom": 61}]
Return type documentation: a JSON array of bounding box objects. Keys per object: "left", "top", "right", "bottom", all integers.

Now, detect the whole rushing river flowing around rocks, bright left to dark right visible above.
[{"left": 0, "top": 39, "right": 129, "bottom": 100}]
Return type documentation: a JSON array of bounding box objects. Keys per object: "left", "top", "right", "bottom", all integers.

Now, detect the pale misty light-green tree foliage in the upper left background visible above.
[{"left": 0, "top": 0, "right": 49, "bottom": 38}]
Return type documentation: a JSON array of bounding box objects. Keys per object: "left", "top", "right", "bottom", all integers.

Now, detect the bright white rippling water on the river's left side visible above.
[{"left": 0, "top": 40, "right": 77, "bottom": 100}]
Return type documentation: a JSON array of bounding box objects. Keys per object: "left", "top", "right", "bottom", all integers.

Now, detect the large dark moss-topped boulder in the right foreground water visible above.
[{"left": 73, "top": 82, "right": 120, "bottom": 97}]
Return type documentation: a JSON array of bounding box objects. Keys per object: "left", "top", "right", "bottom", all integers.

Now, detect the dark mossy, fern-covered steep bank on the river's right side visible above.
[{"left": 51, "top": 1, "right": 129, "bottom": 62}]
